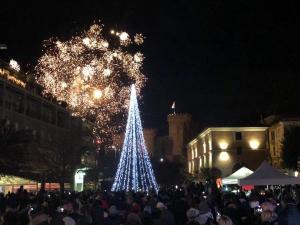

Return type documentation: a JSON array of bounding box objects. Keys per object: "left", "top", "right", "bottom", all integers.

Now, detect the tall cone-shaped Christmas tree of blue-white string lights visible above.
[{"left": 111, "top": 85, "right": 158, "bottom": 192}]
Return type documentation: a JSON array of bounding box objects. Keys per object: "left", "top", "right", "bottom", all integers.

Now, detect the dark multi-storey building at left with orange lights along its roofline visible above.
[{"left": 0, "top": 61, "right": 82, "bottom": 178}]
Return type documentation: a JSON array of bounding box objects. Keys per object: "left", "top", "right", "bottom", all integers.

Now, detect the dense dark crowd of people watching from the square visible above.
[{"left": 0, "top": 184, "right": 298, "bottom": 225}]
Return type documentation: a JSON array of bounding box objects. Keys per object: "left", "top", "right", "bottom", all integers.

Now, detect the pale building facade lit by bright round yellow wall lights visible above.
[{"left": 187, "top": 127, "right": 268, "bottom": 176}]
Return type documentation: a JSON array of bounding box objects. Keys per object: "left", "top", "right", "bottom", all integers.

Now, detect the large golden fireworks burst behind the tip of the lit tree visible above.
[{"left": 36, "top": 24, "right": 145, "bottom": 142}]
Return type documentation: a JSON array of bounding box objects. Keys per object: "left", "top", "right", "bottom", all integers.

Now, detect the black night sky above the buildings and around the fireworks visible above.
[{"left": 0, "top": 0, "right": 300, "bottom": 134}]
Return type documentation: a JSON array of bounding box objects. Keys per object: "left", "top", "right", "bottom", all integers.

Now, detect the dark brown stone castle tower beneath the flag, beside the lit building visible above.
[{"left": 167, "top": 113, "right": 192, "bottom": 160}]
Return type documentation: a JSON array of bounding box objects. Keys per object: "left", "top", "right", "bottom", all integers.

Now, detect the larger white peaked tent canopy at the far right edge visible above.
[{"left": 238, "top": 161, "right": 300, "bottom": 185}]
